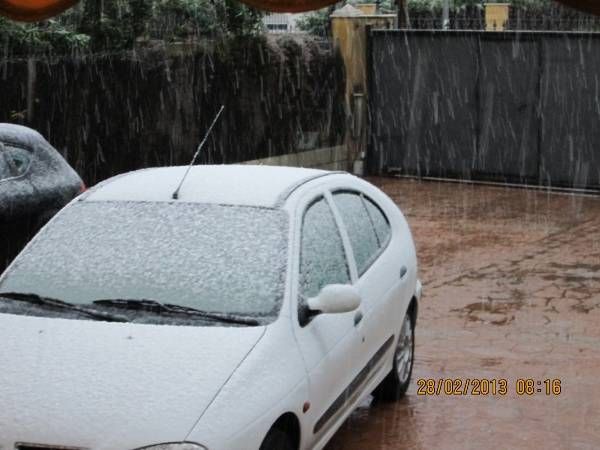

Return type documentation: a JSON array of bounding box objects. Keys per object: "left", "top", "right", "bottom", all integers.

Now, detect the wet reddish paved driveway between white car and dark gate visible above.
[{"left": 327, "top": 179, "right": 600, "bottom": 450}]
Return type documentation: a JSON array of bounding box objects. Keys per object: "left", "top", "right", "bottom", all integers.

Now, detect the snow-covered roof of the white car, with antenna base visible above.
[{"left": 85, "top": 165, "right": 332, "bottom": 207}]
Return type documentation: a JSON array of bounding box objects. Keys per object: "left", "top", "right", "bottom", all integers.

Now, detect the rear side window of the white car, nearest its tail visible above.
[{"left": 333, "top": 191, "right": 390, "bottom": 276}]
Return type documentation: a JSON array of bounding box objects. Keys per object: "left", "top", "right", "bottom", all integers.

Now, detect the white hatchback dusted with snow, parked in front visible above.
[{"left": 0, "top": 166, "right": 421, "bottom": 450}]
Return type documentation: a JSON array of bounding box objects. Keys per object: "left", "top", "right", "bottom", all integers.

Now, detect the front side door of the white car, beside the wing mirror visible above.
[{"left": 294, "top": 195, "right": 360, "bottom": 448}]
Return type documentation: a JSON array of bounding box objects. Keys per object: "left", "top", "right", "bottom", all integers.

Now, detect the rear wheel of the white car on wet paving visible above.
[{"left": 373, "top": 313, "right": 415, "bottom": 401}]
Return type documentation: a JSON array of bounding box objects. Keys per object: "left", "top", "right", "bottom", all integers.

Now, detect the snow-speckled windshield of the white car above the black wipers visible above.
[{"left": 0, "top": 201, "right": 288, "bottom": 316}]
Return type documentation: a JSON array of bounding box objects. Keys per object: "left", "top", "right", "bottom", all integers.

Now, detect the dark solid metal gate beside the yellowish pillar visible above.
[{"left": 368, "top": 30, "right": 600, "bottom": 189}]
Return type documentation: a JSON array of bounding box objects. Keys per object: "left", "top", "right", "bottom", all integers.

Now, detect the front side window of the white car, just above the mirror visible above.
[{"left": 300, "top": 197, "right": 350, "bottom": 298}]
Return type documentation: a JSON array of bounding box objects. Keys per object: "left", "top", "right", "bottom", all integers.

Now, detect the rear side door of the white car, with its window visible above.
[{"left": 332, "top": 189, "right": 411, "bottom": 387}]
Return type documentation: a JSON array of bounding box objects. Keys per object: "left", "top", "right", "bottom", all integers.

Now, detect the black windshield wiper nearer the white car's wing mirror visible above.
[{"left": 92, "top": 298, "right": 260, "bottom": 326}]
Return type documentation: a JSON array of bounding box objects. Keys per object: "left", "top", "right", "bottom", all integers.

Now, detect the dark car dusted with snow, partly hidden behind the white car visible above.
[{"left": 0, "top": 123, "right": 85, "bottom": 272}]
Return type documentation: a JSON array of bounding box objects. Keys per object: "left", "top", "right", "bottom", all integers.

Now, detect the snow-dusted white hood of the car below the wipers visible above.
[{"left": 0, "top": 314, "right": 265, "bottom": 450}]
